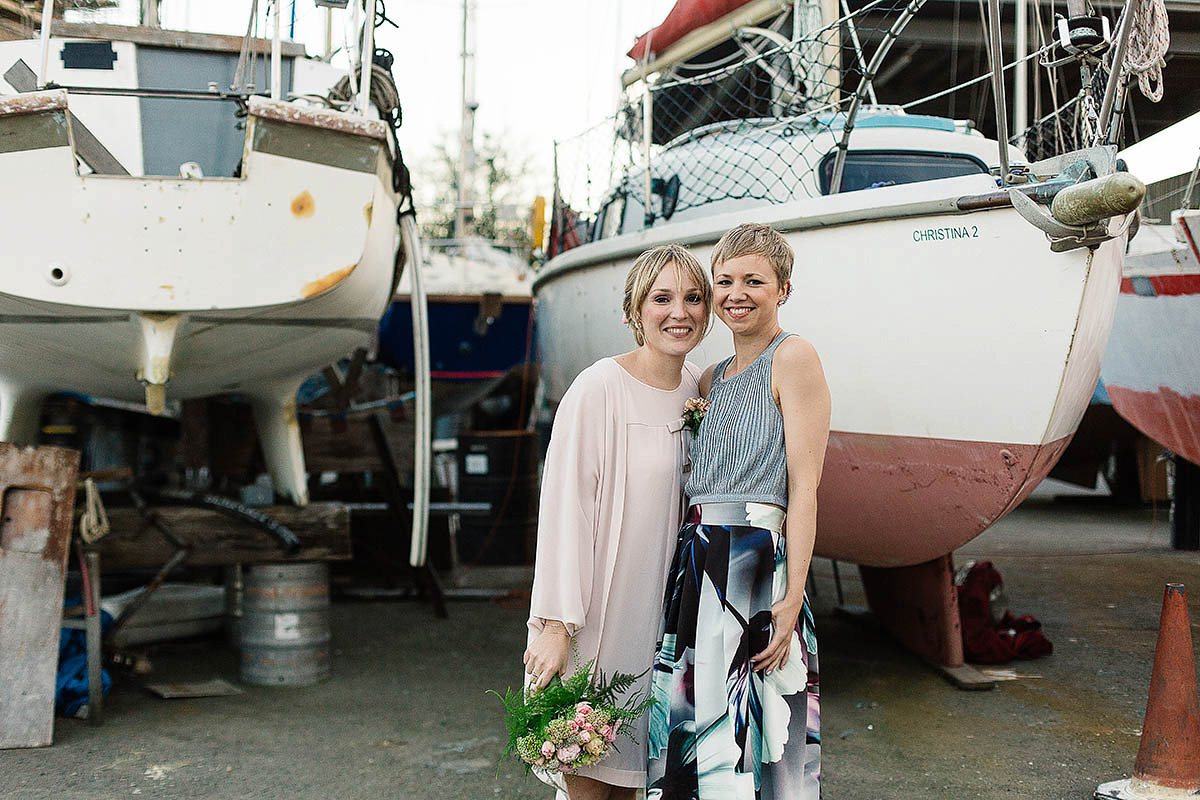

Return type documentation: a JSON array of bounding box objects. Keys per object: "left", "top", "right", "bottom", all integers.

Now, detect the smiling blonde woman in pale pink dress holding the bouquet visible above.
[{"left": 524, "top": 245, "right": 713, "bottom": 800}]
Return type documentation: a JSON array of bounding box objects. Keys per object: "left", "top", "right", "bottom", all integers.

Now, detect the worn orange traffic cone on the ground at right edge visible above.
[{"left": 1096, "top": 583, "right": 1200, "bottom": 800}]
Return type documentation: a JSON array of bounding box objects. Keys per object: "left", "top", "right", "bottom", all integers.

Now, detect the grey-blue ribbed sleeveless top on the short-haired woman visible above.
[{"left": 685, "top": 332, "right": 793, "bottom": 509}]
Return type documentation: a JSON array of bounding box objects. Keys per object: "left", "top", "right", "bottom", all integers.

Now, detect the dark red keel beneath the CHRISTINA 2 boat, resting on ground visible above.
[{"left": 858, "top": 553, "right": 996, "bottom": 690}]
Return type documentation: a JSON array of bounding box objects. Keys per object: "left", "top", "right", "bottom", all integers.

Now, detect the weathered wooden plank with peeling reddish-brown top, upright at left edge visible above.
[{"left": 0, "top": 443, "right": 79, "bottom": 748}]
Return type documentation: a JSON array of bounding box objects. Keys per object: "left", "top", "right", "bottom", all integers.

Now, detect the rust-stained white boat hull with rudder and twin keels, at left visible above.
[{"left": 0, "top": 92, "right": 400, "bottom": 504}]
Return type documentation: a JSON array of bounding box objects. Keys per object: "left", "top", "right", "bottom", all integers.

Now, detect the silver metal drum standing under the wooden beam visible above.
[{"left": 241, "top": 561, "right": 330, "bottom": 686}]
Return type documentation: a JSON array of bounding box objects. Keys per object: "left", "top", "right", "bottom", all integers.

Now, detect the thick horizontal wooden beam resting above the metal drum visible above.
[{"left": 96, "top": 503, "right": 350, "bottom": 570}]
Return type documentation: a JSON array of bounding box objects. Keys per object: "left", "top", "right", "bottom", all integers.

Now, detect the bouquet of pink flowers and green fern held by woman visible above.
[{"left": 490, "top": 661, "right": 654, "bottom": 775}]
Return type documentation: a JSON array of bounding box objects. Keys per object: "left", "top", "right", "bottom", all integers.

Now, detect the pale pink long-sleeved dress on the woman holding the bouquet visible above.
[{"left": 529, "top": 359, "right": 700, "bottom": 787}]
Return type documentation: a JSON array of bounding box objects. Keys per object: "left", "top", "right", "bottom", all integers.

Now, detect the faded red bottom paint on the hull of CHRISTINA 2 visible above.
[{"left": 816, "top": 431, "right": 1070, "bottom": 567}]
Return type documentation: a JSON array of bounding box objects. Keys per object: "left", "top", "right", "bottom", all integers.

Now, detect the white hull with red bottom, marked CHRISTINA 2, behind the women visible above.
[{"left": 535, "top": 175, "right": 1123, "bottom": 566}]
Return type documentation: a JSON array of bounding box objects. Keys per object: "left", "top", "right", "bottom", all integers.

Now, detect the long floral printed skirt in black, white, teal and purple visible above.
[{"left": 647, "top": 503, "right": 821, "bottom": 800}]
